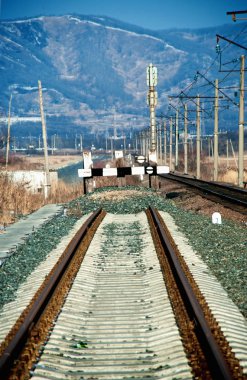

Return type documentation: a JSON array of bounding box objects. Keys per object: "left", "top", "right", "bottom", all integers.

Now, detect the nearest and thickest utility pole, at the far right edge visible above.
[{"left": 238, "top": 55, "right": 245, "bottom": 187}]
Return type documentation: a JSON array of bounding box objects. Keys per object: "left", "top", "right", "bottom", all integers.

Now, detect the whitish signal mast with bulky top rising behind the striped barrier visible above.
[{"left": 147, "top": 63, "right": 157, "bottom": 164}]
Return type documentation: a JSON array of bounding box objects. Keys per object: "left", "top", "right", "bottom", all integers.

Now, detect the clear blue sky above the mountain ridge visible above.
[{"left": 0, "top": 0, "right": 247, "bottom": 30}]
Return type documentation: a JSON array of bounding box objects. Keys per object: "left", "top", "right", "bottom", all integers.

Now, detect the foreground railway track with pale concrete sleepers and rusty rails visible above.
[{"left": 0, "top": 208, "right": 247, "bottom": 380}]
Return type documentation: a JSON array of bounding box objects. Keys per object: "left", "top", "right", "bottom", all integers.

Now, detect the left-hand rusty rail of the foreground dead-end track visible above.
[{"left": 0, "top": 209, "right": 102, "bottom": 380}]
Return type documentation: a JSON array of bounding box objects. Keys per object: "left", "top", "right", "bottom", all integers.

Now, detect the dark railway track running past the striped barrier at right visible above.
[{"left": 159, "top": 173, "right": 247, "bottom": 213}]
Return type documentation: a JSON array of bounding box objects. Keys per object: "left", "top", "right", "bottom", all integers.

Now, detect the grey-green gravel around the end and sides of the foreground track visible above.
[{"left": 0, "top": 187, "right": 247, "bottom": 318}]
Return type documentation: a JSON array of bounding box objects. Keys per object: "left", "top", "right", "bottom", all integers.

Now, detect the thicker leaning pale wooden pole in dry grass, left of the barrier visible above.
[{"left": 38, "top": 80, "right": 51, "bottom": 199}]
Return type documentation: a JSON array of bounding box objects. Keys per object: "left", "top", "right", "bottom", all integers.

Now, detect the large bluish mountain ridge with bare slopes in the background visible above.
[{"left": 0, "top": 15, "right": 247, "bottom": 142}]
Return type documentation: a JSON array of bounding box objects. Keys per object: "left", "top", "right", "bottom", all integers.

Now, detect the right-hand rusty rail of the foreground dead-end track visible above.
[{"left": 149, "top": 207, "right": 232, "bottom": 380}]
